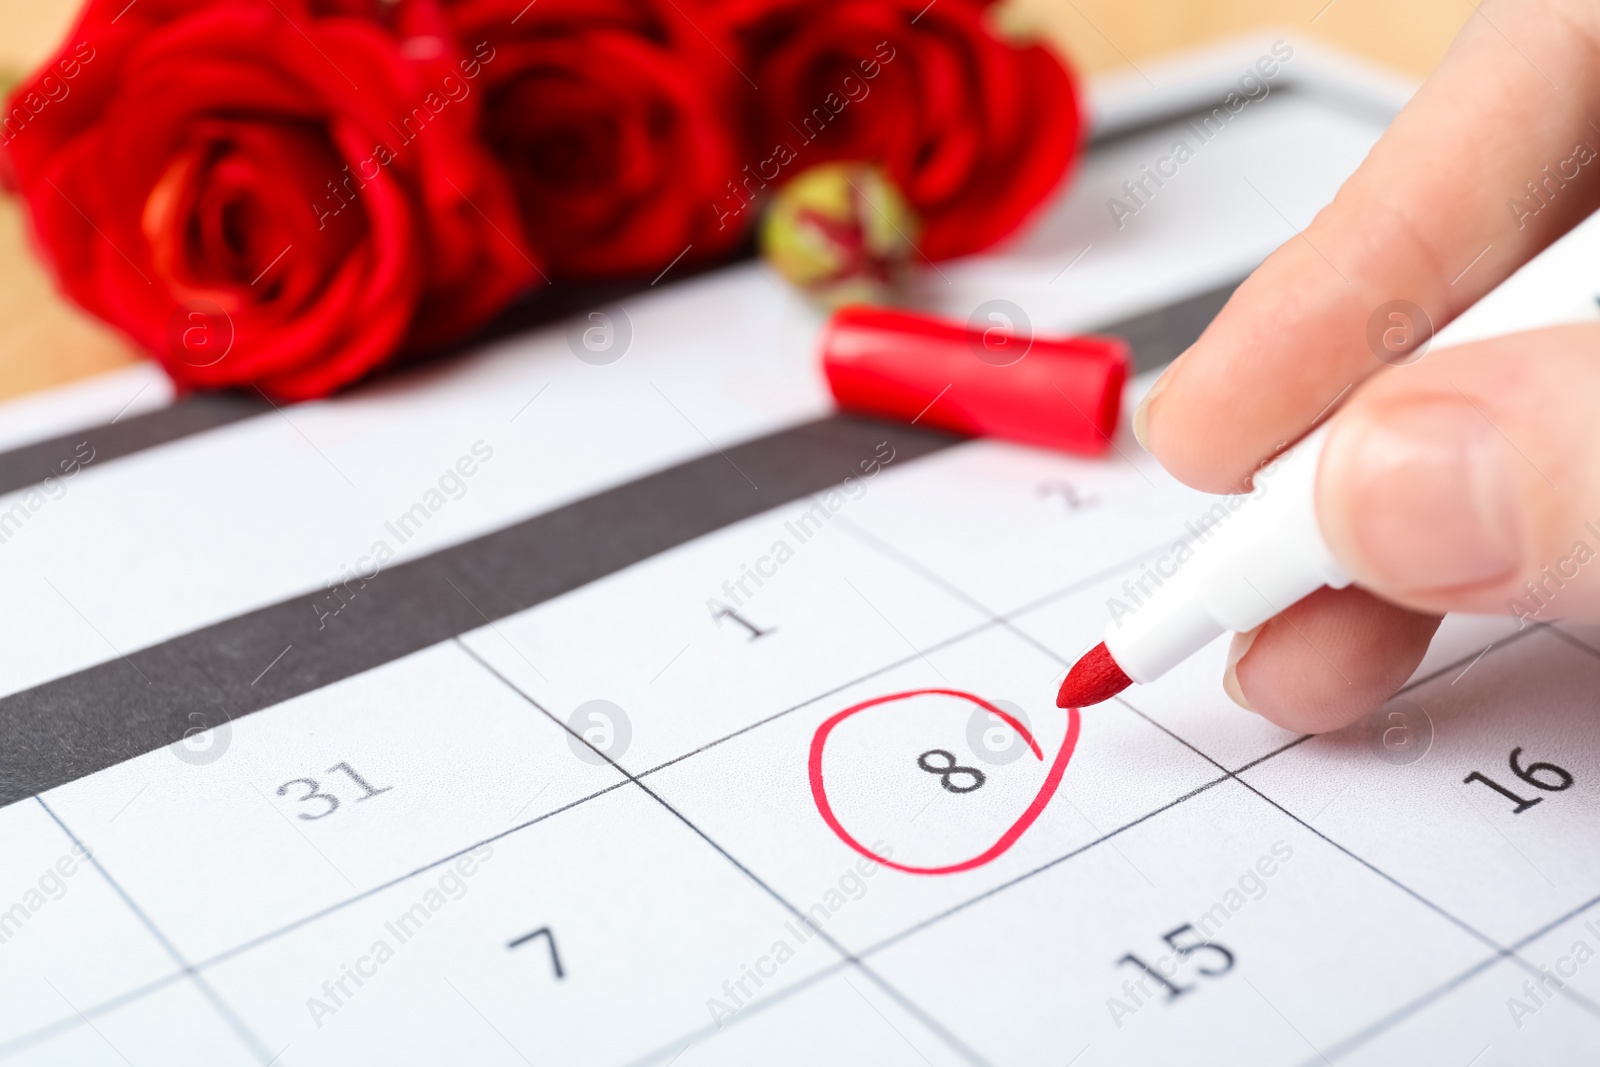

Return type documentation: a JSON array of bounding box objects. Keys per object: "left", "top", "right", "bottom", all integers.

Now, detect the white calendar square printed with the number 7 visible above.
[{"left": 206, "top": 785, "right": 842, "bottom": 1067}]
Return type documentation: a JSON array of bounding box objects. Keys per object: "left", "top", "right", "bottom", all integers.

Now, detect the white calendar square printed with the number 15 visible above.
[{"left": 867, "top": 781, "right": 1482, "bottom": 1065}]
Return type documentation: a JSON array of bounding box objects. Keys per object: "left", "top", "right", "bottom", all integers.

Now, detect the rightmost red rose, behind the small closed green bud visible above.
[{"left": 715, "top": 0, "right": 1083, "bottom": 259}]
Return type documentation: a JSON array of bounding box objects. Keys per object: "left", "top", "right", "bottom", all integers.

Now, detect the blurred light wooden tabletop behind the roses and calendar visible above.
[{"left": 0, "top": 0, "right": 1474, "bottom": 398}]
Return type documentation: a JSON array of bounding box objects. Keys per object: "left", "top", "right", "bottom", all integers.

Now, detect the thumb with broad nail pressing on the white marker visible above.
[{"left": 1317, "top": 325, "right": 1600, "bottom": 622}]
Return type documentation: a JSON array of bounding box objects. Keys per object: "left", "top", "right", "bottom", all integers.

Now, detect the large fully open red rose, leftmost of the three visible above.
[{"left": 5, "top": 0, "right": 533, "bottom": 398}]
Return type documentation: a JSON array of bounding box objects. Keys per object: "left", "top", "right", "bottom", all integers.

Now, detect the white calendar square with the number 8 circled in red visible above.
[{"left": 645, "top": 629, "right": 1221, "bottom": 952}]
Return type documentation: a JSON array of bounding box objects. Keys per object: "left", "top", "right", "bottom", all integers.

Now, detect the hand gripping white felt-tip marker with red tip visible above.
[{"left": 1062, "top": 0, "right": 1600, "bottom": 731}]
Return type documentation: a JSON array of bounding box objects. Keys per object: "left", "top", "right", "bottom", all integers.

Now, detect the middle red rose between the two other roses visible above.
[{"left": 450, "top": 0, "right": 742, "bottom": 278}]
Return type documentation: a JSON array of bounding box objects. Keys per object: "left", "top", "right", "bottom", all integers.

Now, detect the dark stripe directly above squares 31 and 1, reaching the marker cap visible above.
[{"left": 0, "top": 416, "right": 962, "bottom": 805}]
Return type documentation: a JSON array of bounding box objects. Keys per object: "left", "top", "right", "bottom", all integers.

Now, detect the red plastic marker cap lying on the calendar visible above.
[{"left": 822, "top": 301, "right": 1131, "bottom": 454}]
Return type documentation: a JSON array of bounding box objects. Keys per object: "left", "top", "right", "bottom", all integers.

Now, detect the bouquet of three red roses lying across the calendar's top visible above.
[{"left": 0, "top": 0, "right": 1080, "bottom": 398}]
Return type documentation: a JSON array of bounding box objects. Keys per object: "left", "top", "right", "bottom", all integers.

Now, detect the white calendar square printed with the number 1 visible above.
[{"left": 462, "top": 502, "right": 989, "bottom": 773}]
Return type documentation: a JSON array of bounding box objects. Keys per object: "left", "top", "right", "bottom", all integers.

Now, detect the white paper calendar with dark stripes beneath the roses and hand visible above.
[{"left": 0, "top": 38, "right": 1600, "bottom": 1067}]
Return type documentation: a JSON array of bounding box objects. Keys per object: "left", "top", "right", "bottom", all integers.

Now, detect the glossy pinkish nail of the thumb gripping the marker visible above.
[{"left": 1323, "top": 398, "right": 1522, "bottom": 590}]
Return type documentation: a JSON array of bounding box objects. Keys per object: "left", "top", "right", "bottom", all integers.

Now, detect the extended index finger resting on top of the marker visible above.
[{"left": 1134, "top": 0, "right": 1600, "bottom": 493}]
